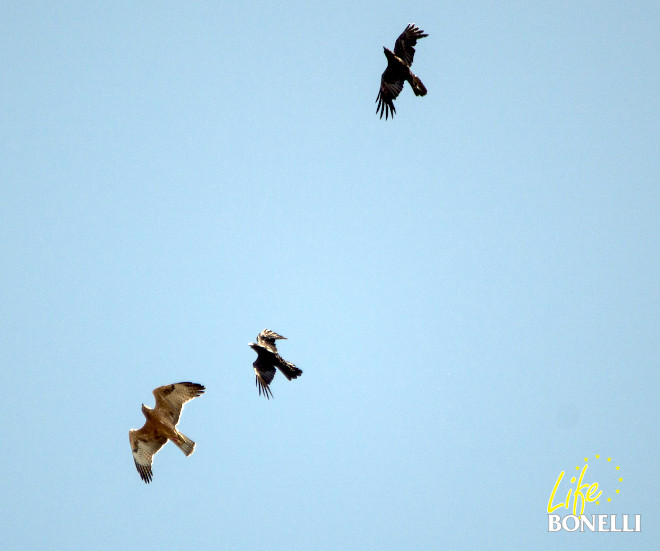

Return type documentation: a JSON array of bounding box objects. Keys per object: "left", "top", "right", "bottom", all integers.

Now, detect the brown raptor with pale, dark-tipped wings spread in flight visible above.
[{"left": 128, "top": 383, "right": 206, "bottom": 484}]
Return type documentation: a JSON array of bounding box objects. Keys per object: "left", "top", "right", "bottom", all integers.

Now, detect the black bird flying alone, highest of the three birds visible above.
[{"left": 376, "top": 23, "right": 428, "bottom": 120}]
